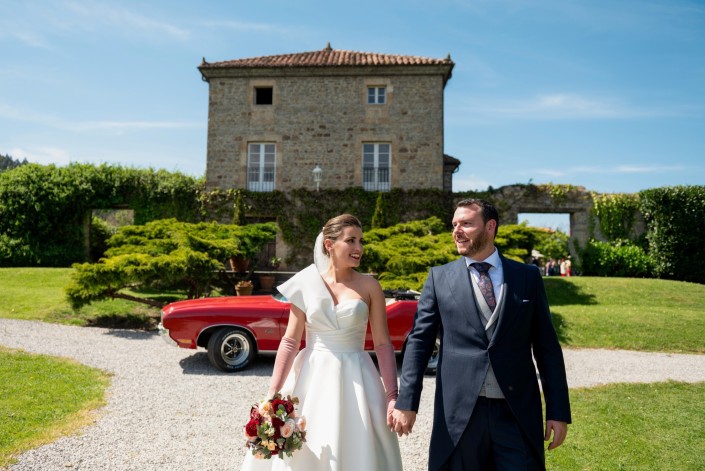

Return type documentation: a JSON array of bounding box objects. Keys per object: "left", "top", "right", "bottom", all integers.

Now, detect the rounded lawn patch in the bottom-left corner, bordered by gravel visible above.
[{"left": 0, "top": 346, "right": 110, "bottom": 468}]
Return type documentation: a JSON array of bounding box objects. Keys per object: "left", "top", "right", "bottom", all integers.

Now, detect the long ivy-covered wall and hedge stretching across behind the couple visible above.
[{"left": 0, "top": 164, "right": 705, "bottom": 283}]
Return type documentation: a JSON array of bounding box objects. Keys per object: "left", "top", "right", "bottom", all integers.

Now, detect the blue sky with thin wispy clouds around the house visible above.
[{"left": 0, "top": 0, "right": 705, "bottom": 230}]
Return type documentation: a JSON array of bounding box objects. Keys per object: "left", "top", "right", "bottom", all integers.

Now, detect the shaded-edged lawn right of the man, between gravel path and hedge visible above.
[{"left": 544, "top": 277, "right": 705, "bottom": 353}]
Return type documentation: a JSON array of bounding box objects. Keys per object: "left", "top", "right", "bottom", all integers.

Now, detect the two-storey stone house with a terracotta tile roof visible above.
[{"left": 198, "top": 45, "right": 460, "bottom": 191}]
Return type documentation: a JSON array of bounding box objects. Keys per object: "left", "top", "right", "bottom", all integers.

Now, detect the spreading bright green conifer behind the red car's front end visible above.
[{"left": 66, "top": 219, "right": 278, "bottom": 308}]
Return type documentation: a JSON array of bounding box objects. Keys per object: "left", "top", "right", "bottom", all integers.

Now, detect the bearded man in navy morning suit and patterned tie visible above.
[{"left": 393, "top": 199, "right": 571, "bottom": 471}]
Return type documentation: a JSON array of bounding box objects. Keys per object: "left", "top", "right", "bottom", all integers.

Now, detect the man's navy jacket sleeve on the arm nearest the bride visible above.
[{"left": 395, "top": 268, "right": 440, "bottom": 411}]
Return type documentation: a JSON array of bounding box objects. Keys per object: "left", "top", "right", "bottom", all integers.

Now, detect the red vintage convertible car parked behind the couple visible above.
[{"left": 159, "top": 291, "right": 438, "bottom": 373}]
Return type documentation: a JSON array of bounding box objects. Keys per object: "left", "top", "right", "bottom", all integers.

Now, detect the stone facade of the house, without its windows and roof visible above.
[{"left": 206, "top": 69, "right": 444, "bottom": 191}]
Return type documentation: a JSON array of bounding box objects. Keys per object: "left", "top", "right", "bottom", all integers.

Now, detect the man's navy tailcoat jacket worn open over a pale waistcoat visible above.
[{"left": 396, "top": 255, "right": 571, "bottom": 470}]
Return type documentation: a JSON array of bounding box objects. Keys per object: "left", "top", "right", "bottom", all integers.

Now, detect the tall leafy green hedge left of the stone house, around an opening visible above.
[{"left": 0, "top": 164, "right": 203, "bottom": 267}]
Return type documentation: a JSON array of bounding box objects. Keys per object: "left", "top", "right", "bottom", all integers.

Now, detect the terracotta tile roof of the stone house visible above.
[{"left": 199, "top": 44, "right": 454, "bottom": 69}]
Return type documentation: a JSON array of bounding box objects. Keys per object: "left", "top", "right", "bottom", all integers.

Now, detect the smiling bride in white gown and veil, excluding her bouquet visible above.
[{"left": 242, "top": 214, "right": 402, "bottom": 471}]
